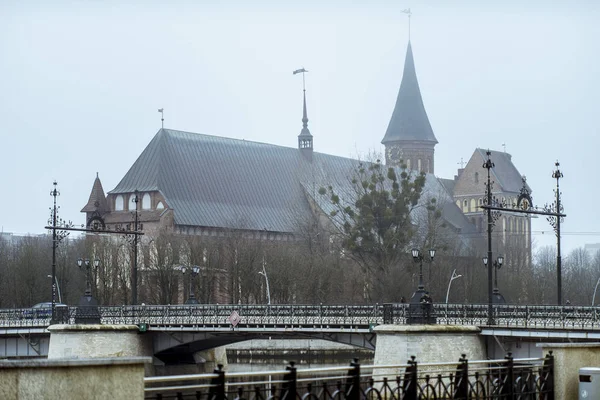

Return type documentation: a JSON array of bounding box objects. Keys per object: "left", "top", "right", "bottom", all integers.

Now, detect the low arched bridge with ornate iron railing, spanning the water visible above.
[{"left": 0, "top": 303, "right": 600, "bottom": 361}]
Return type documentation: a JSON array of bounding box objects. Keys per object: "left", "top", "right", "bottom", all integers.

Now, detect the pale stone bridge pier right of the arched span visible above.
[{"left": 373, "top": 325, "right": 487, "bottom": 372}]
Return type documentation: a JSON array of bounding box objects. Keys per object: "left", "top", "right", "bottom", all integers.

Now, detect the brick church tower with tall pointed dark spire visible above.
[{"left": 381, "top": 41, "right": 438, "bottom": 174}]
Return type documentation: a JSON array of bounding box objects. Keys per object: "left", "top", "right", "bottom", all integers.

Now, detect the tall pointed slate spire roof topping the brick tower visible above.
[{"left": 381, "top": 42, "right": 438, "bottom": 144}]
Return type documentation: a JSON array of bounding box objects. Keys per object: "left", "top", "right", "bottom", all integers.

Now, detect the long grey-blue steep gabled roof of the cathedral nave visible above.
[{"left": 110, "top": 129, "right": 468, "bottom": 233}]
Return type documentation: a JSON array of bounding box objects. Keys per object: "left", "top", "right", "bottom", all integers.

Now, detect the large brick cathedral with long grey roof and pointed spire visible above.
[{"left": 81, "top": 42, "right": 531, "bottom": 263}]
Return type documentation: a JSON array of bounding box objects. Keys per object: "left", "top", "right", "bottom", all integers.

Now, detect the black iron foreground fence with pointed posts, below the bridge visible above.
[{"left": 144, "top": 352, "right": 554, "bottom": 400}]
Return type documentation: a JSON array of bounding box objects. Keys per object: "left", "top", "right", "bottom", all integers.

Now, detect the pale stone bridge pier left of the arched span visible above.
[{"left": 48, "top": 324, "right": 154, "bottom": 375}]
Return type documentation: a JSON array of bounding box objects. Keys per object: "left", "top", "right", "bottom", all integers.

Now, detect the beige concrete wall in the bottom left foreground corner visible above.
[{"left": 0, "top": 357, "right": 151, "bottom": 400}]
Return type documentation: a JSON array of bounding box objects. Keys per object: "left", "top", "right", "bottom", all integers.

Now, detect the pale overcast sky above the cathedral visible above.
[{"left": 0, "top": 0, "right": 600, "bottom": 255}]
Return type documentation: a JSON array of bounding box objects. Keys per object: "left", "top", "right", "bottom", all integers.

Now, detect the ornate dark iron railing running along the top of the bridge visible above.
[{"left": 0, "top": 303, "right": 600, "bottom": 331}]
